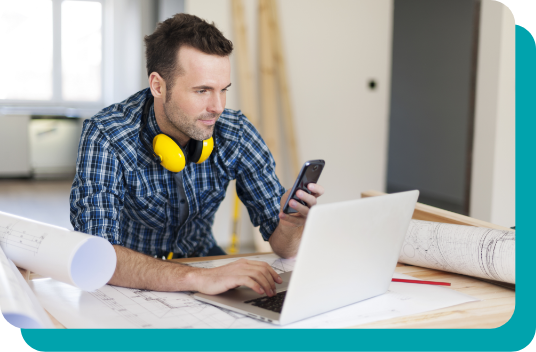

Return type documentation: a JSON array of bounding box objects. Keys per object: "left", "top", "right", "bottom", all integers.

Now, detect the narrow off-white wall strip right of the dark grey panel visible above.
[{"left": 470, "top": 0, "right": 515, "bottom": 227}]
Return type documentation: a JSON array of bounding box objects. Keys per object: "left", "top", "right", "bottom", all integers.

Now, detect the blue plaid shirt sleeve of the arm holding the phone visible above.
[{"left": 236, "top": 115, "right": 285, "bottom": 241}]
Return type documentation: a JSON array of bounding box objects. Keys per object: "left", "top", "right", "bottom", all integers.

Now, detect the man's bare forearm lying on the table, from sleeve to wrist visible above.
[{"left": 108, "top": 245, "right": 196, "bottom": 291}]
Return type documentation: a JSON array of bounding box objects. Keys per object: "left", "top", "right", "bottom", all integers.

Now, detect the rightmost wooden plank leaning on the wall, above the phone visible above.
[{"left": 268, "top": 0, "right": 301, "bottom": 176}]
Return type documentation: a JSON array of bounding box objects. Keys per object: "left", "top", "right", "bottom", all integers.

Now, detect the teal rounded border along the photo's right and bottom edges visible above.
[{"left": 21, "top": 25, "right": 536, "bottom": 352}]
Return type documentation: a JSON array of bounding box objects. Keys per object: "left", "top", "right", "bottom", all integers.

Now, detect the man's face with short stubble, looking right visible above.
[{"left": 164, "top": 46, "right": 231, "bottom": 141}]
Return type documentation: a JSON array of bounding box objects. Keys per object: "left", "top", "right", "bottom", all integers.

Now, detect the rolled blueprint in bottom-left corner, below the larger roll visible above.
[{"left": 0, "top": 249, "right": 54, "bottom": 329}]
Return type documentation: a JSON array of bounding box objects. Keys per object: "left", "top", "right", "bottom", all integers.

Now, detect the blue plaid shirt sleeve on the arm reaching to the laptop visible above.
[{"left": 69, "top": 120, "right": 124, "bottom": 245}]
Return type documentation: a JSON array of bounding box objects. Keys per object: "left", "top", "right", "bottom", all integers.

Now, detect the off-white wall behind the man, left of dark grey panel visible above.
[{"left": 185, "top": 0, "right": 393, "bottom": 246}]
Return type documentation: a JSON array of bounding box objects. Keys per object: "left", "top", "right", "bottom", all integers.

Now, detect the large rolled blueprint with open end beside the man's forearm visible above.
[{"left": 0, "top": 212, "right": 117, "bottom": 291}]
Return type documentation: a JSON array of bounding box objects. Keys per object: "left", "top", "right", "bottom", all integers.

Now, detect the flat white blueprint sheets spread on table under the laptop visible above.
[{"left": 31, "top": 254, "right": 478, "bottom": 329}]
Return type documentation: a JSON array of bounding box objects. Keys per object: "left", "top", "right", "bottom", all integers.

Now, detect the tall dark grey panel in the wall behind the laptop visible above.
[{"left": 387, "top": 0, "right": 475, "bottom": 210}]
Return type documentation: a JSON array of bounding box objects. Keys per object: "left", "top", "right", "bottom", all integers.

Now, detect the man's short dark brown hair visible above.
[{"left": 144, "top": 13, "right": 233, "bottom": 95}]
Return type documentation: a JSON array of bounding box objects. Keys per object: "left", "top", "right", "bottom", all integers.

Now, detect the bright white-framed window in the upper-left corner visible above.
[{"left": 0, "top": 0, "right": 103, "bottom": 106}]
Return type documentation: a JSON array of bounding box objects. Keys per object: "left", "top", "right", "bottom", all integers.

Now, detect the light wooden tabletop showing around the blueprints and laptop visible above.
[{"left": 21, "top": 190, "right": 515, "bottom": 329}]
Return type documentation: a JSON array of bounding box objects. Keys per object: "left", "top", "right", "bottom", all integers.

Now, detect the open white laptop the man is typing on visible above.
[{"left": 194, "top": 191, "right": 419, "bottom": 325}]
